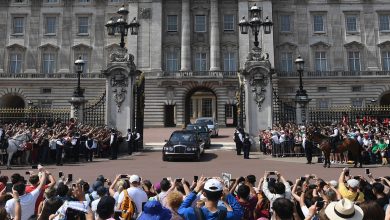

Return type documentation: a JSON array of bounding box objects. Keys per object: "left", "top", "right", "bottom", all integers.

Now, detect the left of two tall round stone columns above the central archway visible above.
[{"left": 180, "top": 0, "right": 191, "bottom": 71}]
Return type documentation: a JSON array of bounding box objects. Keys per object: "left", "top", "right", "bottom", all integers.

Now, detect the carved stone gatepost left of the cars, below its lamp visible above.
[{"left": 102, "top": 48, "right": 139, "bottom": 136}]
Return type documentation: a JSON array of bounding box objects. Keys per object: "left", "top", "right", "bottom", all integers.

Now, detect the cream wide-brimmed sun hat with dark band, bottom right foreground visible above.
[{"left": 325, "top": 199, "right": 364, "bottom": 220}]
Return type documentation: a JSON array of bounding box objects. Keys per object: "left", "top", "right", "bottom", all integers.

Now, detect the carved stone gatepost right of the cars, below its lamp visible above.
[{"left": 240, "top": 47, "right": 272, "bottom": 150}]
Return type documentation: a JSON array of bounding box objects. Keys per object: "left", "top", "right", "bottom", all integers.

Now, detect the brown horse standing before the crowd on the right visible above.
[{"left": 307, "top": 131, "right": 362, "bottom": 168}]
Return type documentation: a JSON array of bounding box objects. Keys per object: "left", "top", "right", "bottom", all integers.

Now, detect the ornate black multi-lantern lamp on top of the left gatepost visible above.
[{"left": 105, "top": 5, "right": 140, "bottom": 48}]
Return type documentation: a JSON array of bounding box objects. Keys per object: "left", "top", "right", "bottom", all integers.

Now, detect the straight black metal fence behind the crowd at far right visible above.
[{"left": 309, "top": 106, "right": 390, "bottom": 124}]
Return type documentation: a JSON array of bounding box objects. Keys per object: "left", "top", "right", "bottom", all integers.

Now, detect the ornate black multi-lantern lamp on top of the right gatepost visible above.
[{"left": 238, "top": 4, "right": 273, "bottom": 47}]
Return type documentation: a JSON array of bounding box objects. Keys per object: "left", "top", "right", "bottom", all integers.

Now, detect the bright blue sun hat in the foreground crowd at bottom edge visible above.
[{"left": 138, "top": 200, "right": 172, "bottom": 220}]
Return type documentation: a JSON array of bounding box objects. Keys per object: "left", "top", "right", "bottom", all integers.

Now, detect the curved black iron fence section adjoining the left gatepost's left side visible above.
[{"left": 83, "top": 92, "right": 106, "bottom": 126}]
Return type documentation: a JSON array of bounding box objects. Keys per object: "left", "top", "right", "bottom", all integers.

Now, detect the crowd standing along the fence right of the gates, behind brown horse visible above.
[{"left": 259, "top": 120, "right": 390, "bottom": 165}]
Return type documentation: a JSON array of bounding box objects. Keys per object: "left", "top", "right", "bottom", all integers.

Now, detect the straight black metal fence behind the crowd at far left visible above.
[{"left": 0, "top": 108, "right": 70, "bottom": 125}]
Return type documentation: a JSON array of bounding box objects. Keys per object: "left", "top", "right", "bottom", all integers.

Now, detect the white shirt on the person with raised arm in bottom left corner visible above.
[{"left": 5, "top": 188, "right": 40, "bottom": 220}]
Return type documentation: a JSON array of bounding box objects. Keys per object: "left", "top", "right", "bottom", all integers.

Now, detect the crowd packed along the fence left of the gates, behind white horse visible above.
[{"left": 0, "top": 119, "right": 140, "bottom": 166}]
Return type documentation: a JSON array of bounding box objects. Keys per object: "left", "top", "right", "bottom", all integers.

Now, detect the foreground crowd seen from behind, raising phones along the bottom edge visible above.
[{"left": 0, "top": 165, "right": 390, "bottom": 220}]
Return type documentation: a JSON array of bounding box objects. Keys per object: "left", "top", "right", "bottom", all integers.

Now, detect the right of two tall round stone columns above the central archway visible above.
[{"left": 210, "top": 0, "right": 221, "bottom": 71}]
